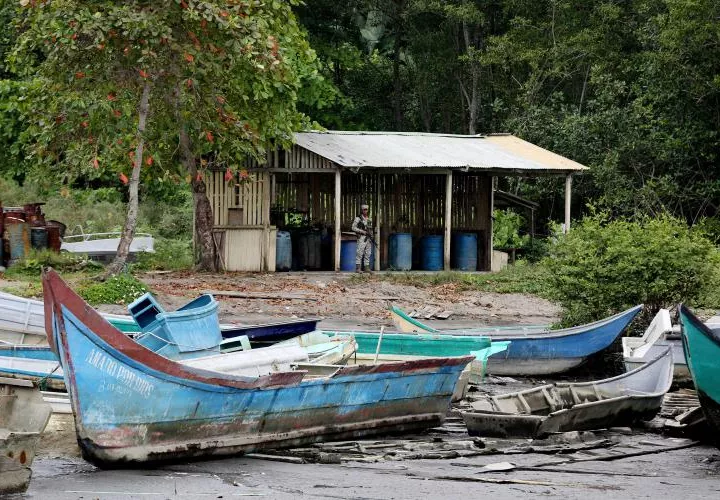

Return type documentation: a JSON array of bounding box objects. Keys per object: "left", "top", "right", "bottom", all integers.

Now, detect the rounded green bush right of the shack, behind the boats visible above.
[{"left": 542, "top": 213, "right": 718, "bottom": 325}]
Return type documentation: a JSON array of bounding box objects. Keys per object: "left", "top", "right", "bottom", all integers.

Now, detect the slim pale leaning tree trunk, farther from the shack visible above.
[{"left": 105, "top": 80, "right": 150, "bottom": 277}]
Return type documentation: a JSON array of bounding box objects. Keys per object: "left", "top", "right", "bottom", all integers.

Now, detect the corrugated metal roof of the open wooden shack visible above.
[{"left": 295, "top": 131, "right": 587, "bottom": 174}]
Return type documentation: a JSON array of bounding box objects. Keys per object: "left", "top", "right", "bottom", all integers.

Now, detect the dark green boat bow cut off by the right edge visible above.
[{"left": 678, "top": 304, "right": 720, "bottom": 440}]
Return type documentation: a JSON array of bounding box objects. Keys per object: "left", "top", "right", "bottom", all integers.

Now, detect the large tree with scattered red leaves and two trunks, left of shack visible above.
[{"left": 9, "top": 0, "right": 321, "bottom": 271}]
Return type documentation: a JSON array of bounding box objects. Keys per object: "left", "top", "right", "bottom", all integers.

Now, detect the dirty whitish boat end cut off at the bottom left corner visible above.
[{"left": 0, "top": 378, "right": 52, "bottom": 496}]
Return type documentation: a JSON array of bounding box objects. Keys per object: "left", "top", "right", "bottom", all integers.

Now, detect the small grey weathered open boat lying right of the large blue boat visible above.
[{"left": 463, "top": 348, "right": 673, "bottom": 438}]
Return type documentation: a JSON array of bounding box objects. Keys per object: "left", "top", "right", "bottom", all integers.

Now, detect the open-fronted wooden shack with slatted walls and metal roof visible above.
[{"left": 207, "top": 131, "right": 586, "bottom": 271}]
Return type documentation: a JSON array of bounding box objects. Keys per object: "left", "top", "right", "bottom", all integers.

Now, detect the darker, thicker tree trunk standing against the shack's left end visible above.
[{"left": 180, "top": 124, "right": 218, "bottom": 272}]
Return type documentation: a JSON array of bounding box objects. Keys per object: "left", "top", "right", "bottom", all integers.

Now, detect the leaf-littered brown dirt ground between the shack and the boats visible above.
[{"left": 101, "top": 273, "right": 560, "bottom": 329}]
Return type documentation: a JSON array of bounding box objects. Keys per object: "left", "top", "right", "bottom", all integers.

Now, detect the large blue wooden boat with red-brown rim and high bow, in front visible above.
[{"left": 43, "top": 270, "right": 473, "bottom": 467}]
